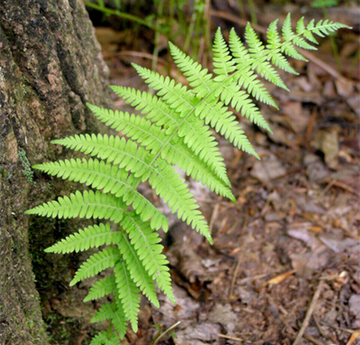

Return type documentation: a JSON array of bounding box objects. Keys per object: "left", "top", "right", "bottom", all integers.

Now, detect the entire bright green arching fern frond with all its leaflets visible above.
[{"left": 27, "top": 15, "right": 346, "bottom": 344}]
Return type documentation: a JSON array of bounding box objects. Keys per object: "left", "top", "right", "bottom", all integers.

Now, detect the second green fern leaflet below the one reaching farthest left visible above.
[{"left": 70, "top": 247, "right": 121, "bottom": 286}]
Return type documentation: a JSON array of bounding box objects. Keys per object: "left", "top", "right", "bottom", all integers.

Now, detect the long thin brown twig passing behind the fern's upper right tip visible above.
[{"left": 210, "top": 10, "right": 351, "bottom": 83}]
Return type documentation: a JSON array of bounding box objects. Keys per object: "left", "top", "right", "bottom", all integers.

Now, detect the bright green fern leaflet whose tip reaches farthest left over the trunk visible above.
[{"left": 25, "top": 190, "right": 126, "bottom": 223}]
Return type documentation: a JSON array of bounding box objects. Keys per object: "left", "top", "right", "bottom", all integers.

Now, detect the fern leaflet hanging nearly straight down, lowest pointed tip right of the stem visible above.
[{"left": 114, "top": 260, "right": 140, "bottom": 333}]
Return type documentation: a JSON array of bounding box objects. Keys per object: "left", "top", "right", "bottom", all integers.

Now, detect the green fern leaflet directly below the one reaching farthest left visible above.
[{"left": 45, "top": 223, "right": 121, "bottom": 253}]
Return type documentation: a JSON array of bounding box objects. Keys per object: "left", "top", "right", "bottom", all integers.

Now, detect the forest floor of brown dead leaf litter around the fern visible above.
[{"left": 43, "top": 4, "right": 360, "bottom": 345}]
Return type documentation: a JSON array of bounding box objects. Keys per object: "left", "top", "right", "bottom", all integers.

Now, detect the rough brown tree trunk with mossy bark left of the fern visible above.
[{"left": 0, "top": 0, "right": 109, "bottom": 345}]
